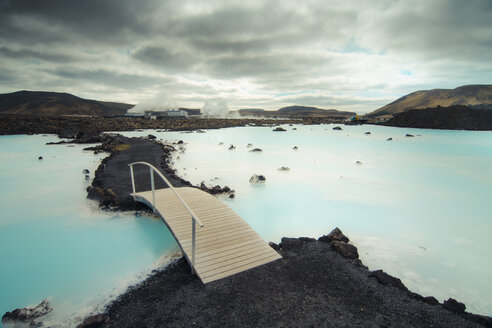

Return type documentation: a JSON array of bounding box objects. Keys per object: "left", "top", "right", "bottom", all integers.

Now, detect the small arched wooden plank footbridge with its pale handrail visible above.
[{"left": 129, "top": 162, "right": 281, "bottom": 283}]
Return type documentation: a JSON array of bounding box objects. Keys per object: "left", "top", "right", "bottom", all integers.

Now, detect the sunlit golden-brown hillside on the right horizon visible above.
[{"left": 367, "top": 85, "right": 492, "bottom": 117}]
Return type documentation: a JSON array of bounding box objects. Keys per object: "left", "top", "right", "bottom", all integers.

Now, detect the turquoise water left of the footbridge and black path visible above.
[{"left": 0, "top": 136, "right": 175, "bottom": 327}]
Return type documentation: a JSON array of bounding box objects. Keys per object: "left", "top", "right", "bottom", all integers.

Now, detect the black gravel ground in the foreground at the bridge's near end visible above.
[{"left": 102, "top": 238, "right": 481, "bottom": 328}]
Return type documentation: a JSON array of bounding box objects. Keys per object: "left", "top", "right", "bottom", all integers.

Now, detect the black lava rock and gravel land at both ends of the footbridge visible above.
[{"left": 1, "top": 129, "right": 492, "bottom": 328}]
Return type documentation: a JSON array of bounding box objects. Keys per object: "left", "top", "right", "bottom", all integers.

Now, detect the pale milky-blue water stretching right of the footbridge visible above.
[{"left": 122, "top": 125, "right": 492, "bottom": 315}]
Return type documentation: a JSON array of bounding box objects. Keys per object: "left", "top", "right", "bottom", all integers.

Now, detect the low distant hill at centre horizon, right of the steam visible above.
[{"left": 239, "top": 106, "right": 355, "bottom": 119}]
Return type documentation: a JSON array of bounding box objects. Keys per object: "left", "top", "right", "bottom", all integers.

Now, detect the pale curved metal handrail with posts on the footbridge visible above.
[{"left": 128, "top": 162, "right": 203, "bottom": 273}]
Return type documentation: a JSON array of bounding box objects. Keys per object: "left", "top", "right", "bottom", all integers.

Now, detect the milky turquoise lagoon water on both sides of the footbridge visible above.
[{"left": 0, "top": 125, "right": 492, "bottom": 326}]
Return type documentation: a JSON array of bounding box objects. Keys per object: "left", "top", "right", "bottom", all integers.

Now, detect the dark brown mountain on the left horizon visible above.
[{"left": 0, "top": 91, "right": 133, "bottom": 116}]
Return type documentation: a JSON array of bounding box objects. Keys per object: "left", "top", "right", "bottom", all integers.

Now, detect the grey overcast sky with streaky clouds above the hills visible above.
[{"left": 0, "top": 0, "right": 492, "bottom": 113}]
